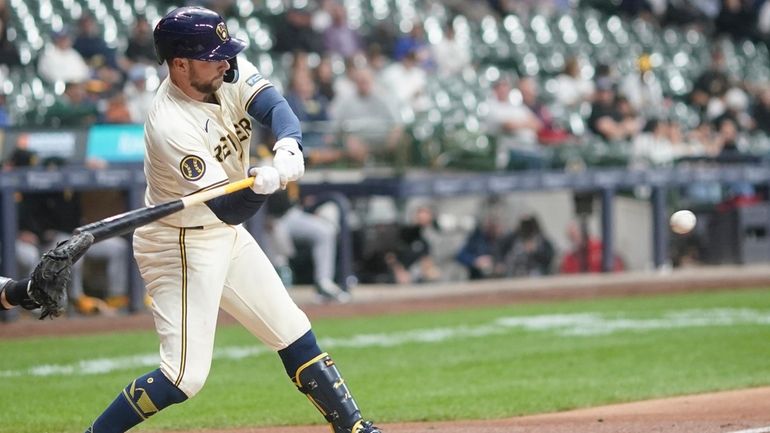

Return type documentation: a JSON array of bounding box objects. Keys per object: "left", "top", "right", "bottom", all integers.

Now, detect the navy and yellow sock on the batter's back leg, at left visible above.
[{"left": 85, "top": 369, "right": 187, "bottom": 433}]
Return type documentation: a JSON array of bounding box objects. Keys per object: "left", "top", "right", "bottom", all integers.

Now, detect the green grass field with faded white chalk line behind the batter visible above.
[{"left": 0, "top": 290, "right": 770, "bottom": 433}]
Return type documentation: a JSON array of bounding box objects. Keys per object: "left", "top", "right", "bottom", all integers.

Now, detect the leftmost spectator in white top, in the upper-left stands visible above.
[{"left": 37, "top": 29, "right": 91, "bottom": 83}]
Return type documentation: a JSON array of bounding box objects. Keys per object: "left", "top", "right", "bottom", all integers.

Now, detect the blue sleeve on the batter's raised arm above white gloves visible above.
[{"left": 248, "top": 87, "right": 302, "bottom": 149}]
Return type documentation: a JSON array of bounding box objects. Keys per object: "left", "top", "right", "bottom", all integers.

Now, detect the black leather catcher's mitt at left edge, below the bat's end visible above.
[{"left": 27, "top": 232, "right": 94, "bottom": 319}]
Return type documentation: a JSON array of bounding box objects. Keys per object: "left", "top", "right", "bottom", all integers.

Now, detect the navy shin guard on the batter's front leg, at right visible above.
[{"left": 294, "top": 353, "right": 363, "bottom": 433}]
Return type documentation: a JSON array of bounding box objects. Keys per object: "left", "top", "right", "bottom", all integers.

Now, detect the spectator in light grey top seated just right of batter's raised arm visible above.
[{"left": 332, "top": 67, "right": 403, "bottom": 163}]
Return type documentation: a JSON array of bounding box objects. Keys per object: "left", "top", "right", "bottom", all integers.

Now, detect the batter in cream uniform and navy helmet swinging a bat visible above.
[{"left": 86, "top": 7, "right": 380, "bottom": 433}]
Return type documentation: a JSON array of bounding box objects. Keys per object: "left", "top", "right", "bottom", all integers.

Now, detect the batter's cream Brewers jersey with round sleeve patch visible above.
[{"left": 144, "top": 56, "right": 271, "bottom": 227}]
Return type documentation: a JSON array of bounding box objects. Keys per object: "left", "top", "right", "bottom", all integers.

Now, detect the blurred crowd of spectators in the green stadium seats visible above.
[{"left": 0, "top": 0, "right": 770, "bottom": 169}]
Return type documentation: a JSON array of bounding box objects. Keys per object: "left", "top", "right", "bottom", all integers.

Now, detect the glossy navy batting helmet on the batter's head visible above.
[{"left": 153, "top": 6, "right": 246, "bottom": 81}]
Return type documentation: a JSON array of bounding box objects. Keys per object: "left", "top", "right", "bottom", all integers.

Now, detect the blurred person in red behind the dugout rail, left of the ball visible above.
[{"left": 559, "top": 222, "right": 625, "bottom": 274}]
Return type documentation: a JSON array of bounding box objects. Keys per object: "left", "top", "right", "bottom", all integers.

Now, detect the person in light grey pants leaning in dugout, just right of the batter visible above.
[{"left": 267, "top": 184, "right": 350, "bottom": 302}]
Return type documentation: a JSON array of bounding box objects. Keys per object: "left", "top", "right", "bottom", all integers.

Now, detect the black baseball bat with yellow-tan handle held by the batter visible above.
[{"left": 75, "top": 177, "right": 254, "bottom": 242}]
